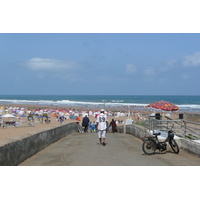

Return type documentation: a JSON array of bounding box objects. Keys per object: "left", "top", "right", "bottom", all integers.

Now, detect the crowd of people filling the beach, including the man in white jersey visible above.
[{"left": 0, "top": 106, "right": 156, "bottom": 146}]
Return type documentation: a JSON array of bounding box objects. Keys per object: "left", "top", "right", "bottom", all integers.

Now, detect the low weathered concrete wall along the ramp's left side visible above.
[{"left": 0, "top": 123, "right": 79, "bottom": 166}]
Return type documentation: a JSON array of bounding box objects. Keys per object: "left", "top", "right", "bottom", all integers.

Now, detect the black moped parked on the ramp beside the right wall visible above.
[{"left": 142, "top": 125, "right": 179, "bottom": 155}]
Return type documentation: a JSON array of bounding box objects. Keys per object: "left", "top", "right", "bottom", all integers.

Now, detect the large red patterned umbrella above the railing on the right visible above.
[{"left": 146, "top": 101, "right": 178, "bottom": 111}]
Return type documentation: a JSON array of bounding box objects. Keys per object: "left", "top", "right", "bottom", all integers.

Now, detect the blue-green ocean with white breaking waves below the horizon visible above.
[{"left": 0, "top": 95, "right": 200, "bottom": 113}]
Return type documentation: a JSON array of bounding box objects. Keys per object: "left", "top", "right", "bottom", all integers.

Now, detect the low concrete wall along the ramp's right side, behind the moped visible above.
[{"left": 117, "top": 125, "right": 200, "bottom": 157}]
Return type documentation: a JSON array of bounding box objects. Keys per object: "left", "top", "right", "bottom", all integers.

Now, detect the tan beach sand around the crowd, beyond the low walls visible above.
[{"left": 0, "top": 105, "right": 195, "bottom": 141}]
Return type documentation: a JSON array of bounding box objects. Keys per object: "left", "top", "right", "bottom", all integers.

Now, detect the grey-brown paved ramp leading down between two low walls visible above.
[{"left": 19, "top": 133, "right": 200, "bottom": 166}]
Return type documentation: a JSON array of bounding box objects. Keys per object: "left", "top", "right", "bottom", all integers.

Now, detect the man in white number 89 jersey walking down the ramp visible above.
[{"left": 96, "top": 109, "right": 108, "bottom": 146}]
